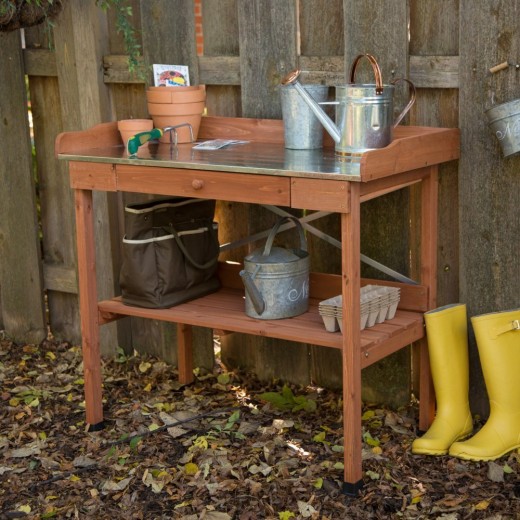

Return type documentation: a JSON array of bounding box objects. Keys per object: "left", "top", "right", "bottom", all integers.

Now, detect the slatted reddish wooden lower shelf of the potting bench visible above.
[{"left": 98, "top": 287, "right": 424, "bottom": 368}]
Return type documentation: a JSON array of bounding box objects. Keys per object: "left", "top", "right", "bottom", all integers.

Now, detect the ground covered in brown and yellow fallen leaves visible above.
[{"left": 0, "top": 340, "right": 520, "bottom": 520}]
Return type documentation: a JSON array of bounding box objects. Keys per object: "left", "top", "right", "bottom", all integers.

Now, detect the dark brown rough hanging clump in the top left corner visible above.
[{"left": 0, "top": 0, "right": 63, "bottom": 32}]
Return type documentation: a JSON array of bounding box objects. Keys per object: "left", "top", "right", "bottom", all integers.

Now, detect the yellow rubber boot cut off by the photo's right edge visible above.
[{"left": 450, "top": 309, "right": 520, "bottom": 460}]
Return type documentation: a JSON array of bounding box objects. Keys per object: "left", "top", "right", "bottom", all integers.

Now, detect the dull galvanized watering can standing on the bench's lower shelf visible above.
[{"left": 240, "top": 217, "right": 310, "bottom": 320}]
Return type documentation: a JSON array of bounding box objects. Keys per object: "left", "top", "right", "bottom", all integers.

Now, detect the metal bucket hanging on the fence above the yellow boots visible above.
[{"left": 486, "top": 99, "right": 520, "bottom": 157}]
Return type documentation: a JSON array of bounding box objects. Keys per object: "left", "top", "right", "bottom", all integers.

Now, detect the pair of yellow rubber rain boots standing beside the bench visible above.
[{"left": 412, "top": 304, "right": 520, "bottom": 461}]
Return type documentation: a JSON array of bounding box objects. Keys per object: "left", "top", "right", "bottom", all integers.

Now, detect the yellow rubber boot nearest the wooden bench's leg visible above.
[{"left": 412, "top": 304, "right": 473, "bottom": 455}]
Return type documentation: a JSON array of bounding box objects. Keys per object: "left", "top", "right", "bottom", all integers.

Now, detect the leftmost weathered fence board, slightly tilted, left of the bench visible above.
[{"left": 0, "top": 31, "right": 47, "bottom": 342}]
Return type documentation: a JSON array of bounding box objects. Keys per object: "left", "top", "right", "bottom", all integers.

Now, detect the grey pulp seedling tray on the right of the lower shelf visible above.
[{"left": 318, "top": 285, "right": 401, "bottom": 332}]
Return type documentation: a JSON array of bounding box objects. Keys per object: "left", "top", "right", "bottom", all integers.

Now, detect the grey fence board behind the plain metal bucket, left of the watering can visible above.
[{"left": 221, "top": 0, "right": 309, "bottom": 383}]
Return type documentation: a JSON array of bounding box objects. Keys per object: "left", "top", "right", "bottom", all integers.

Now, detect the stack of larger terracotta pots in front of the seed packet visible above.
[{"left": 146, "top": 85, "right": 206, "bottom": 143}]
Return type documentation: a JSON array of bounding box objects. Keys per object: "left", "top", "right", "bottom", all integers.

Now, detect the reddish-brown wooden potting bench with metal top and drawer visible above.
[{"left": 56, "top": 117, "right": 459, "bottom": 496}]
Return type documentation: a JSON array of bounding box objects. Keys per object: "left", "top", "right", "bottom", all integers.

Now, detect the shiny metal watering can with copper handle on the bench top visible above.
[{"left": 282, "top": 54, "right": 415, "bottom": 155}]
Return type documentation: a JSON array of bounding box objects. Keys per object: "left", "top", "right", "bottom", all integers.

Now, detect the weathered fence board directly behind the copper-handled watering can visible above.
[{"left": 343, "top": 0, "right": 411, "bottom": 404}]
